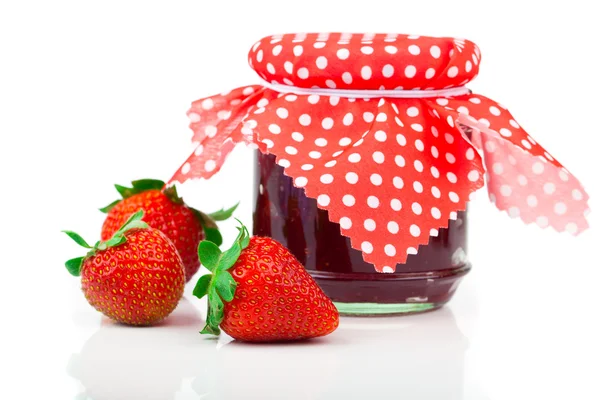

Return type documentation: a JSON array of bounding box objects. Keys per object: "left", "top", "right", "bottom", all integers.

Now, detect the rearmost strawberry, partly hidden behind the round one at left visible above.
[{"left": 101, "top": 179, "right": 237, "bottom": 281}]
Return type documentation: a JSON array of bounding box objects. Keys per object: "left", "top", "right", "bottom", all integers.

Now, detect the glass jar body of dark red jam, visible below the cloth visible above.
[{"left": 254, "top": 152, "right": 470, "bottom": 315}]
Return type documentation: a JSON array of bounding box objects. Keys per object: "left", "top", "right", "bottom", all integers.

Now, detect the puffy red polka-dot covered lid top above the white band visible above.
[{"left": 248, "top": 33, "right": 481, "bottom": 90}]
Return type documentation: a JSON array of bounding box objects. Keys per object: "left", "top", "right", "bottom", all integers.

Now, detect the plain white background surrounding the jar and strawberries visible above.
[{"left": 0, "top": 0, "right": 600, "bottom": 400}]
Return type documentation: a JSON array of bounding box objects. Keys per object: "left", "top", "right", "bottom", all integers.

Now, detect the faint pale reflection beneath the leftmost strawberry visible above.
[{"left": 68, "top": 298, "right": 216, "bottom": 400}]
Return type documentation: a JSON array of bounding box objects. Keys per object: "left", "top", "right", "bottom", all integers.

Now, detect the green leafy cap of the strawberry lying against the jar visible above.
[{"left": 193, "top": 220, "right": 250, "bottom": 335}]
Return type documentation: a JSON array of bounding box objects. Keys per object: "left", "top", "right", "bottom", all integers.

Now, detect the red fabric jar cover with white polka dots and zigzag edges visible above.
[{"left": 171, "top": 33, "right": 589, "bottom": 272}]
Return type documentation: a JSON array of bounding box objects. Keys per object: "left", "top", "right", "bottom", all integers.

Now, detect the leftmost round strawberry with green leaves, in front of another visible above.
[{"left": 64, "top": 210, "right": 185, "bottom": 325}]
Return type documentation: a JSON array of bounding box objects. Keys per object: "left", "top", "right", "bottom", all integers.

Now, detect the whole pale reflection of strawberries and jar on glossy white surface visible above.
[{"left": 68, "top": 299, "right": 482, "bottom": 400}]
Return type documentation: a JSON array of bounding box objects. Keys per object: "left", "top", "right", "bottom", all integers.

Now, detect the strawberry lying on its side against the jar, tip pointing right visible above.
[{"left": 194, "top": 225, "right": 339, "bottom": 342}]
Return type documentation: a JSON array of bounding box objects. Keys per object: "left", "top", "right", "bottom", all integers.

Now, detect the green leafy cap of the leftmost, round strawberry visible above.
[{"left": 63, "top": 210, "right": 149, "bottom": 276}]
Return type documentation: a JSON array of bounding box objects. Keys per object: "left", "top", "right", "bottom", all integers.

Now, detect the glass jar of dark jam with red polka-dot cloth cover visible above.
[{"left": 172, "top": 33, "right": 588, "bottom": 315}]
